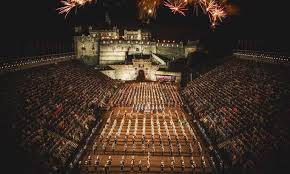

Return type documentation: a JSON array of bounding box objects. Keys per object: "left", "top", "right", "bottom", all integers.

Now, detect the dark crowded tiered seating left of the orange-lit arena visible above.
[{"left": 2, "top": 62, "right": 118, "bottom": 172}]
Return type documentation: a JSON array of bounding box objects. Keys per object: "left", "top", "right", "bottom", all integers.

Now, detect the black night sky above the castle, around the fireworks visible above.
[{"left": 0, "top": 0, "right": 290, "bottom": 57}]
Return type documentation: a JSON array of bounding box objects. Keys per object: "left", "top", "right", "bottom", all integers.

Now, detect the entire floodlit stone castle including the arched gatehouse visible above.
[{"left": 74, "top": 27, "right": 198, "bottom": 82}]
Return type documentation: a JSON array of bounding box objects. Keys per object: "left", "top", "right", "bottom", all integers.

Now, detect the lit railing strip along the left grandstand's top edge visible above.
[{"left": 0, "top": 52, "right": 75, "bottom": 72}]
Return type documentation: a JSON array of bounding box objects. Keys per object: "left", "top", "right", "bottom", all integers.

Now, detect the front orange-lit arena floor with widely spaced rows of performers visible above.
[{"left": 80, "top": 82, "right": 211, "bottom": 174}]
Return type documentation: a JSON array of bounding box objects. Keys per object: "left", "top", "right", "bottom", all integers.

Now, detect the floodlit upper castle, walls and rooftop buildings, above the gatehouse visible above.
[{"left": 75, "top": 27, "right": 197, "bottom": 65}]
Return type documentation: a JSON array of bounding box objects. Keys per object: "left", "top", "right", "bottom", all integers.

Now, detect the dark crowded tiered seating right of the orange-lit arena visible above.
[{"left": 182, "top": 60, "right": 290, "bottom": 170}]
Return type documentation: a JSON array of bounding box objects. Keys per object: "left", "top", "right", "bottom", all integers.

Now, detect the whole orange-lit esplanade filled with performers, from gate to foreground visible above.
[{"left": 79, "top": 82, "right": 211, "bottom": 173}]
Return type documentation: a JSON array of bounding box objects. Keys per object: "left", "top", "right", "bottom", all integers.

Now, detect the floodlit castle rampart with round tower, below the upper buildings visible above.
[{"left": 75, "top": 35, "right": 194, "bottom": 65}]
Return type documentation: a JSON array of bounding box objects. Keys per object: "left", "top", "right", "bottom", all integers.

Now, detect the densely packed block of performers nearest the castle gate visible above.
[{"left": 110, "top": 82, "right": 183, "bottom": 111}]
